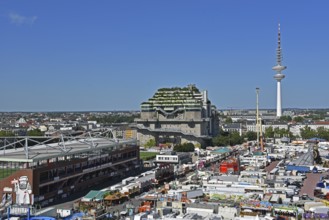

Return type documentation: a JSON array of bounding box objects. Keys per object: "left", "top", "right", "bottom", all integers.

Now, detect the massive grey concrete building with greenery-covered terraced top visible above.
[{"left": 135, "top": 85, "right": 219, "bottom": 145}]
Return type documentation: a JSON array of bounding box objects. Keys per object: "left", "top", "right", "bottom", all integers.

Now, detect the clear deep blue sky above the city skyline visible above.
[{"left": 0, "top": 0, "right": 329, "bottom": 111}]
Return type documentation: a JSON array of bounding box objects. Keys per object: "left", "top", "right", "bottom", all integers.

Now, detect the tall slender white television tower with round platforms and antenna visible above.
[{"left": 272, "top": 24, "right": 287, "bottom": 117}]
